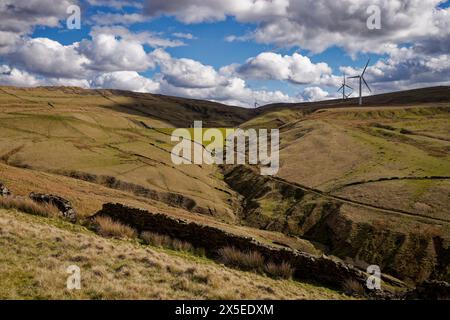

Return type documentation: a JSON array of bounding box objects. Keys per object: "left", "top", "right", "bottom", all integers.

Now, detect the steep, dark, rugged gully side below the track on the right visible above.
[{"left": 223, "top": 166, "right": 450, "bottom": 283}]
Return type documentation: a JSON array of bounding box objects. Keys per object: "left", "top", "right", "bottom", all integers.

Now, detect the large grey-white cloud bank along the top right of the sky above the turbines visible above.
[{"left": 145, "top": 0, "right": 450, "bottom": 53}]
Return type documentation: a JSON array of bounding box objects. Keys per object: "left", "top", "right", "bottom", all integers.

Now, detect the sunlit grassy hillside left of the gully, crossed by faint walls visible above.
[{"left": 0, "top": 88, "right": 248, "bottom": 221}]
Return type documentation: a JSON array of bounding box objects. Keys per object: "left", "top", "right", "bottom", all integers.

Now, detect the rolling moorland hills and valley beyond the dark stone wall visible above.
[{"left": 0, "top": 87, "right": 450, "bottom": 296}]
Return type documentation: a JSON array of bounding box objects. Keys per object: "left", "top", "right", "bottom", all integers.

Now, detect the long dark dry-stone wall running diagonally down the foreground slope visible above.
[{"left": 92, "top": 203, "right": 380, "bottom": 296}]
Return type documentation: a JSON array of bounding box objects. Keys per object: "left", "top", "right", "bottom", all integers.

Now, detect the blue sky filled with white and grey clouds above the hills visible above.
[{"left": 0, "top": 0, "right": 450, "bottom": 108}]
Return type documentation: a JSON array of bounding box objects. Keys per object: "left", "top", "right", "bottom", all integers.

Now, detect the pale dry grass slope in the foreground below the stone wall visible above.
[{"left": 0, "top": 209, "right": 347, "bottom": 300}]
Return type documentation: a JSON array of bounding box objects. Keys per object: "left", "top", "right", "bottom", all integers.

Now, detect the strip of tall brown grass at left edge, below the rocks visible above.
[{"left": 0, "top": 197, "right": 59, "bottom": 217}]
